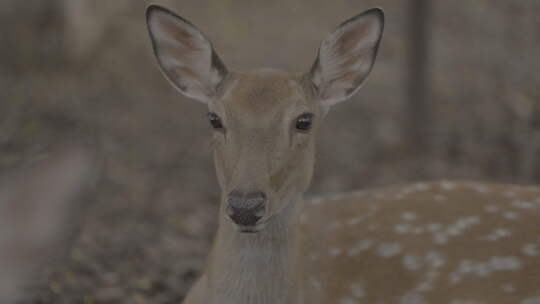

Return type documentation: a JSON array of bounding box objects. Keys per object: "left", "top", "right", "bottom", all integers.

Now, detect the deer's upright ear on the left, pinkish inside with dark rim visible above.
[{"left": 146, "top": 5, "right": 227, "bottom": 103}]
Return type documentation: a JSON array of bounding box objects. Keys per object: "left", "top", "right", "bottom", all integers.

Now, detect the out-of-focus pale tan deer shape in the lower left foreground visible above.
[{"left": 0, "top": 142, "right": 98, "bottom": 304}]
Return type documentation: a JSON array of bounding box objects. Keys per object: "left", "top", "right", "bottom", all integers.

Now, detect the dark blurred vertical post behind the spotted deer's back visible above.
[{"left": 407, "top": 0, "right": 431, "bottom": 178}]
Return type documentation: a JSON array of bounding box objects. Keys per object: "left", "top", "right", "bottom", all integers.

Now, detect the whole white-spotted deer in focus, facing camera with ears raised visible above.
[{"left": 146, "top": 4, "right": 540, "bottom": 304}]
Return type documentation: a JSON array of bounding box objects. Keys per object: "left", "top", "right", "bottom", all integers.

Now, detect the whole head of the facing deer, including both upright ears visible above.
[{"left": 147, "top": 6, "right": 383, "bottom": 232}]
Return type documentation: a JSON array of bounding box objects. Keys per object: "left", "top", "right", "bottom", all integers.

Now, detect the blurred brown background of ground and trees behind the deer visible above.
[{"left": 0, "top": 0, "right": 540, "bottom": 304}]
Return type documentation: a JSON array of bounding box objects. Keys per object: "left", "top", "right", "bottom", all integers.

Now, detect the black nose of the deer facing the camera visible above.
[{"left": 227, "top": 190, "right": 266, "bottom": 226}]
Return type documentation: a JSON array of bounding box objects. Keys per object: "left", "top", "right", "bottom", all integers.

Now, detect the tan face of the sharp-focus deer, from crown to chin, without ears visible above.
[{"left": 209, "top": 69, "right": 321, "bottom": 230}]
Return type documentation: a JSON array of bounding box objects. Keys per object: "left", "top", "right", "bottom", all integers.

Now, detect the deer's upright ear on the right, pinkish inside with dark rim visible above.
[{"left": 309, "top": 8, "right": 384, "bottom": 107}]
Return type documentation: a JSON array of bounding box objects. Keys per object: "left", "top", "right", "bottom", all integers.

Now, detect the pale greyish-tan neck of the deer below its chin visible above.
[{"left": 206, "top": 196, "right": 302, "bottom": 304}]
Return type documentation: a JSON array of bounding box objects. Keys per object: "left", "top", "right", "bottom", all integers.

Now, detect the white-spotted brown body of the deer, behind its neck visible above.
[{"left": 300, "top": 181, "right": 540, "bottom": 304}]
